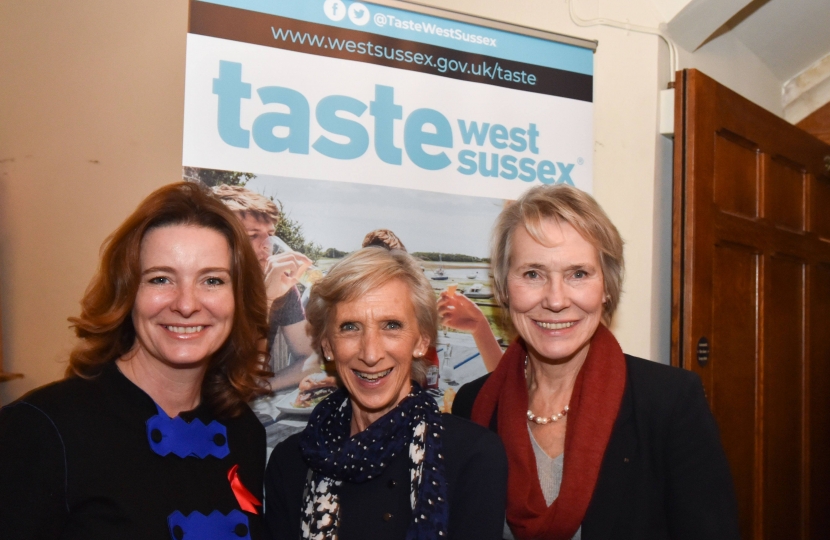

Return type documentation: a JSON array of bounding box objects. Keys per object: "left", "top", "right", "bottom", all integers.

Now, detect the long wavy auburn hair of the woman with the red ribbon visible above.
[{"left": 67, "top": 182, "right": 271, "bottom": 417}]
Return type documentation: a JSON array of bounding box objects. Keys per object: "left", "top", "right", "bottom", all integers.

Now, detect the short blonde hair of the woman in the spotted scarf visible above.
[{"left": 306, "top": 246, "right": 438, "bottom": 384}]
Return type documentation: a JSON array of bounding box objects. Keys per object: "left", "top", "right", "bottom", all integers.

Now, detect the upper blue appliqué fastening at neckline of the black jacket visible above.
[{"left": 147, "top": 405, "right": 231, "bottom": 459}]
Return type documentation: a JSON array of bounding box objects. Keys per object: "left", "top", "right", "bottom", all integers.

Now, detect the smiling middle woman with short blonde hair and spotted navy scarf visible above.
[{"left": 265, "top": 247, "right": 507, "bottom": 540}]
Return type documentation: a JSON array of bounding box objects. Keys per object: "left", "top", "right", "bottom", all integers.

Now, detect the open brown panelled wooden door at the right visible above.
[{"left": 672, "top": 70, "right": 830, "bottom": 540}]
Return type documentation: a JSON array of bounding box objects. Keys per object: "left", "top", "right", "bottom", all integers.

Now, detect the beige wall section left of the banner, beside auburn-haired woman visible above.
[{"left": 0, "top": 0, "right": 187, "bottom": 403}]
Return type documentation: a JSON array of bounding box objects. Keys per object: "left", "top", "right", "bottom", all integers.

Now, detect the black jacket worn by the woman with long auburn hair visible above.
[{"left": 0, "top": 363, "right": 265, "bottom": 540}]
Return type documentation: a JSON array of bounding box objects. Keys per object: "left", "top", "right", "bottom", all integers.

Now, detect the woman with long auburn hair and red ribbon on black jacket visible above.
[{"left": 0, "top": 183, "right": 270, "bottom": 540}]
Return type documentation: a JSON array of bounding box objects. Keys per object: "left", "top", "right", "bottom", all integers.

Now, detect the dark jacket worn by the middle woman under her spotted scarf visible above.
[{"left": 264, "top": 414, "right": 507, "bottom": 540}]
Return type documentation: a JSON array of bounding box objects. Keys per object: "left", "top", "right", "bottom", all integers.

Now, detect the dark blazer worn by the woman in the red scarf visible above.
[{"left": 453, "top": 355, "right": 740, "bottom": 540}]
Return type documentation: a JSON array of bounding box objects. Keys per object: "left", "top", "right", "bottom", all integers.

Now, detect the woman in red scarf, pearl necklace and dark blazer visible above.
[{"left": 453, "top": 185, "right": 739, "bottom": 540}]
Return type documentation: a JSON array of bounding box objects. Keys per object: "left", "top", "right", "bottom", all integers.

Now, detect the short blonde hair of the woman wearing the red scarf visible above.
[{"left": 491, "top": 184, "right": 625, "bottom": 324}]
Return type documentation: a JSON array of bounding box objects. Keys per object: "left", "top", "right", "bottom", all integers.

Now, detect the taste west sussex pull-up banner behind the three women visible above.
[{"left": 183, "top": 0, "right": 595, "bottom": 447}]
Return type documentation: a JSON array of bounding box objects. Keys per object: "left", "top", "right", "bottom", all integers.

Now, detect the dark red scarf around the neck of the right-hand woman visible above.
[{"left": 472, "top": 325, "right": 626, "bottom": 540}]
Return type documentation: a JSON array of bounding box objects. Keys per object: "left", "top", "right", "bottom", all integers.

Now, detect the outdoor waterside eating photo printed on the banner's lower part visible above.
[{"left": 189, "top": 167, "right": 509, "bottom": 448}]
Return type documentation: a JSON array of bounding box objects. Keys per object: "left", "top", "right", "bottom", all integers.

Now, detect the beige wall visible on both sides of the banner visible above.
[{"left": 0, "top": 0, "right": 781, "bottom": 403}]
